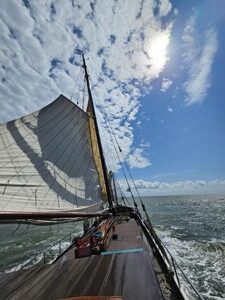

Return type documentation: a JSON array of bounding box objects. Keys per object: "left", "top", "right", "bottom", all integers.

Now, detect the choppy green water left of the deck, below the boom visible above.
[{"left": 0, "top": 222, "right": 82, "bottom": 272}]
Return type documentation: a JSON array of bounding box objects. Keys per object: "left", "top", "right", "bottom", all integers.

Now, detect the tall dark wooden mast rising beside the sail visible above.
[{"left": 82, "top": 53, "right": 113, "bottom": 207}]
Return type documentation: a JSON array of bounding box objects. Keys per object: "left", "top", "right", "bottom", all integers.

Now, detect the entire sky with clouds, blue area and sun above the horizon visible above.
[{"left": 0, "top": 0, "right": 225, "bottom": 195}]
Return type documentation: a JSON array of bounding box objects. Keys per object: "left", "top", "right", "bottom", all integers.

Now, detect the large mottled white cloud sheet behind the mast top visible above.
[{"left": 0, "top": 0, "right": 172, "bottom": 169}]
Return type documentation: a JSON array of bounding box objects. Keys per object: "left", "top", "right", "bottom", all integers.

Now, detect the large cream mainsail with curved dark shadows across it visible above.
[{"left": 0, "top": 95, "right": 105, "bottom": 212}]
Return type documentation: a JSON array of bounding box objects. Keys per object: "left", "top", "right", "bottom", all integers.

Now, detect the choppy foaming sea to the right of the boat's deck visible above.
[{"left": 141, "top": 195, "right": 225, "bottom": 300}]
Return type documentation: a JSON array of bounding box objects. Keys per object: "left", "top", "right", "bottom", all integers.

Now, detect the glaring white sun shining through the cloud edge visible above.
[{"left": 148, "top": 34, "right": 169, "bottom": 70}]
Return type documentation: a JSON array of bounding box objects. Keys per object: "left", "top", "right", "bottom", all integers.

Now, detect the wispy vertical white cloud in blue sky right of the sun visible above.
[{"left": 182, "top": 12, "right": 218, "bottom": 105}]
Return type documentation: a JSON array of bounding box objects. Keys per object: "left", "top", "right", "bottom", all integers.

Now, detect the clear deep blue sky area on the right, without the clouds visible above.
[{"left": 118, "top": 1, "right": 225, "bottom": 194}]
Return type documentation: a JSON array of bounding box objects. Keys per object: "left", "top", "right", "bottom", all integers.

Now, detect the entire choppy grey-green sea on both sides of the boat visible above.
[{"left": 0, "top": 195, "right": 225, "bottom": 300}]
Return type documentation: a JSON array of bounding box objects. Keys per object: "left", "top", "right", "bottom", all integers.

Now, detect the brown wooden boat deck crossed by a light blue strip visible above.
[{"left": 0, "top": 221, "right": 162, "bottom": 300}]
